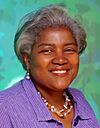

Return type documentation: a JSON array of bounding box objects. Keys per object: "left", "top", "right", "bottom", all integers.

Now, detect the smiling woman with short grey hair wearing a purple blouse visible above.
[{"left": 0, "top": 6, "right": 99, "bottom": 128}]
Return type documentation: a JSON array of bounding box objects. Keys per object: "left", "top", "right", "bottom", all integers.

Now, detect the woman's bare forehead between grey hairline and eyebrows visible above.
[{"left": 33, "top": 26, "right": 76, "bottom": 45}]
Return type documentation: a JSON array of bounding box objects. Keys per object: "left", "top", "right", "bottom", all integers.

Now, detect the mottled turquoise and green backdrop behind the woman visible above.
[{"left": 0, "top": 0, "right": 100, "bottom": 120}]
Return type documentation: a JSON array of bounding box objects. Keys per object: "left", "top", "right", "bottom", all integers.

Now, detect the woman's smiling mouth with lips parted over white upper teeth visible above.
[{"left": 51, "top": 69, "right": 70, "bottom": 77}]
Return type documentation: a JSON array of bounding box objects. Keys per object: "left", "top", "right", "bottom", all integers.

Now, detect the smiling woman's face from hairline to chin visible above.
[{"left": 26, "top": 27, "right": 79, "bottom": 91}]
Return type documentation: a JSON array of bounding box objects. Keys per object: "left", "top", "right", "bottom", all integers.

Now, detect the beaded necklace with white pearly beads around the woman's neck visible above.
[{"left": 38, "top": 92, "right": 73, "bottom": 118}]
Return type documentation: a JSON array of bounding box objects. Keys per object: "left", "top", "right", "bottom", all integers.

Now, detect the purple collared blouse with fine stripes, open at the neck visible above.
[{"left": 0, "top": 79, "right": 100, "bottom": 128}]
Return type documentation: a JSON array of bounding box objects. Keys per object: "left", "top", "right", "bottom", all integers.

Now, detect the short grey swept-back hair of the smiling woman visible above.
[{"left": 14, "top": 5, "right": 87, "bottom": 69}]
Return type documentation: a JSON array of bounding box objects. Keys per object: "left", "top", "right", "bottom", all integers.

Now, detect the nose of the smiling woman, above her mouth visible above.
[{"left": 52, "top": 54, "right": 68, "bottom": 65}]
